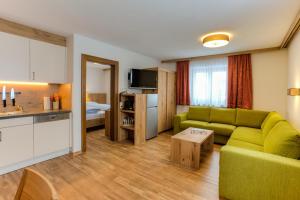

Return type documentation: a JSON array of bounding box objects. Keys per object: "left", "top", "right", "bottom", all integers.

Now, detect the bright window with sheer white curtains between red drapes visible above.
[{"left": 190, "top": 58, "right": 228, "bottom": 107}]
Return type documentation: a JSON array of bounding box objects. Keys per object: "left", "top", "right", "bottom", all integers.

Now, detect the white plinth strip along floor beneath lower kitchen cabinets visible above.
[{"left": 0, "top": 148, "right": 70, "bottom": 175}]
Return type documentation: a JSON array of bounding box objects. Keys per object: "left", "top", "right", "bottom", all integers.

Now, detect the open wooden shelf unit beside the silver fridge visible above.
[{"left": 118, "top": 94, "right": 147, "bottom": 145}]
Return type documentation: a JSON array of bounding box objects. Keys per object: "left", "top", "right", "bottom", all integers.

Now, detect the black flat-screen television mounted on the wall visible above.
[{"left": 128, "top": 69, "right": 157, "bottom": 89}]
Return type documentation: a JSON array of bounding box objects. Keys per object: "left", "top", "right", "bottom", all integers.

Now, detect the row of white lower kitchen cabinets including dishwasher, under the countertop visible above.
[{"left": 0, "top": 113, "right": 70, "bottom": 175}]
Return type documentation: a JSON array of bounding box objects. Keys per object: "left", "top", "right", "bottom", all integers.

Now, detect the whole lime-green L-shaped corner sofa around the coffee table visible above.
[{"left": 174, "top": 107, "right": 300, "bottom": 200}]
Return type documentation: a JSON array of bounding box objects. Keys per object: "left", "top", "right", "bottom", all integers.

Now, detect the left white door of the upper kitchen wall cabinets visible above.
[{"left": 0, "top": 32, "right": 30, "bottom": 81}]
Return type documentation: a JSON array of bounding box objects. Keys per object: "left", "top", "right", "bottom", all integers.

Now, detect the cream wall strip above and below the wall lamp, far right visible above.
[{"left": 287, "top": 31, "right": 300, "bottom": 129}]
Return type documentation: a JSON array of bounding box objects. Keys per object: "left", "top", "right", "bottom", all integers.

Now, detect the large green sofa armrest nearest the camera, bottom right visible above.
[{"left": 219, "top": 145, "right": 300, "bottom": 200}]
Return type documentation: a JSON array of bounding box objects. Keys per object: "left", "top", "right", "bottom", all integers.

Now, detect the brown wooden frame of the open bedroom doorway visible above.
[{"left": 81, "top": 54, "right": 119, "bottom": 152}]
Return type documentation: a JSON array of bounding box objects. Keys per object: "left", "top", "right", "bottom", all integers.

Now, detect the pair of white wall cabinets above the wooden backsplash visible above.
[{"left": 0, "top": 32, "right": 67, "bottom": 83}]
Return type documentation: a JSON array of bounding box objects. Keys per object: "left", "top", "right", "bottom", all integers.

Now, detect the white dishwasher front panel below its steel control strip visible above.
[{"left": 34, "top": 119, "right": 70, "bottom": 157}]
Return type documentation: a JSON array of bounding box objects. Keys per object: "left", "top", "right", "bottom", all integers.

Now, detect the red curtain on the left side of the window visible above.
[{"left": 176, "top": 61, "right": 190, "bottom": 105}]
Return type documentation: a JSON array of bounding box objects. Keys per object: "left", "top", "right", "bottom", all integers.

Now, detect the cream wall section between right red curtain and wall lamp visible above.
[{"left": 251, "top": 49, "right": 288, "bottom": 117}]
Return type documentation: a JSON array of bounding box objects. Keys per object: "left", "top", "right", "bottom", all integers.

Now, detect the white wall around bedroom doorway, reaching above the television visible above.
[{"left": 68, "top": 34, "right": 159, "bottom": 152}]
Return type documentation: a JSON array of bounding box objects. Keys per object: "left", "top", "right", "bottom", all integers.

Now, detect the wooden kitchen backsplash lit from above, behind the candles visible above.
[{"left": 0, "top": 84, "right": 60, "bottom": 112}]
